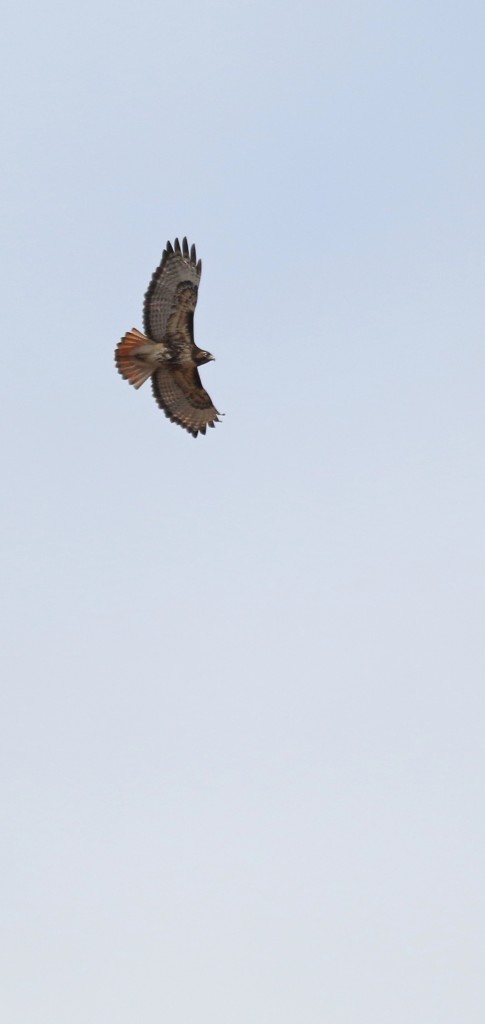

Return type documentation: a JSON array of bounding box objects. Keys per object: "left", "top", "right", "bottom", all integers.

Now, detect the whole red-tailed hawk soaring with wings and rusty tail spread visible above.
[{"left": 115, "top": 239, "right": 220, "bottom": 437}]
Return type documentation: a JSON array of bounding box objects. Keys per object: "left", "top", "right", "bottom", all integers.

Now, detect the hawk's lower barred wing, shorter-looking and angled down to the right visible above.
[{"left": 151, "top": 365, "right": 219, "bottom": 437}]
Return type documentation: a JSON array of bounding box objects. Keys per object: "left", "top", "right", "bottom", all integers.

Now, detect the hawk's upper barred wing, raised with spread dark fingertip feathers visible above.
[{"left": 143, "top": 239, "right": 202, "bottom": 354}]
